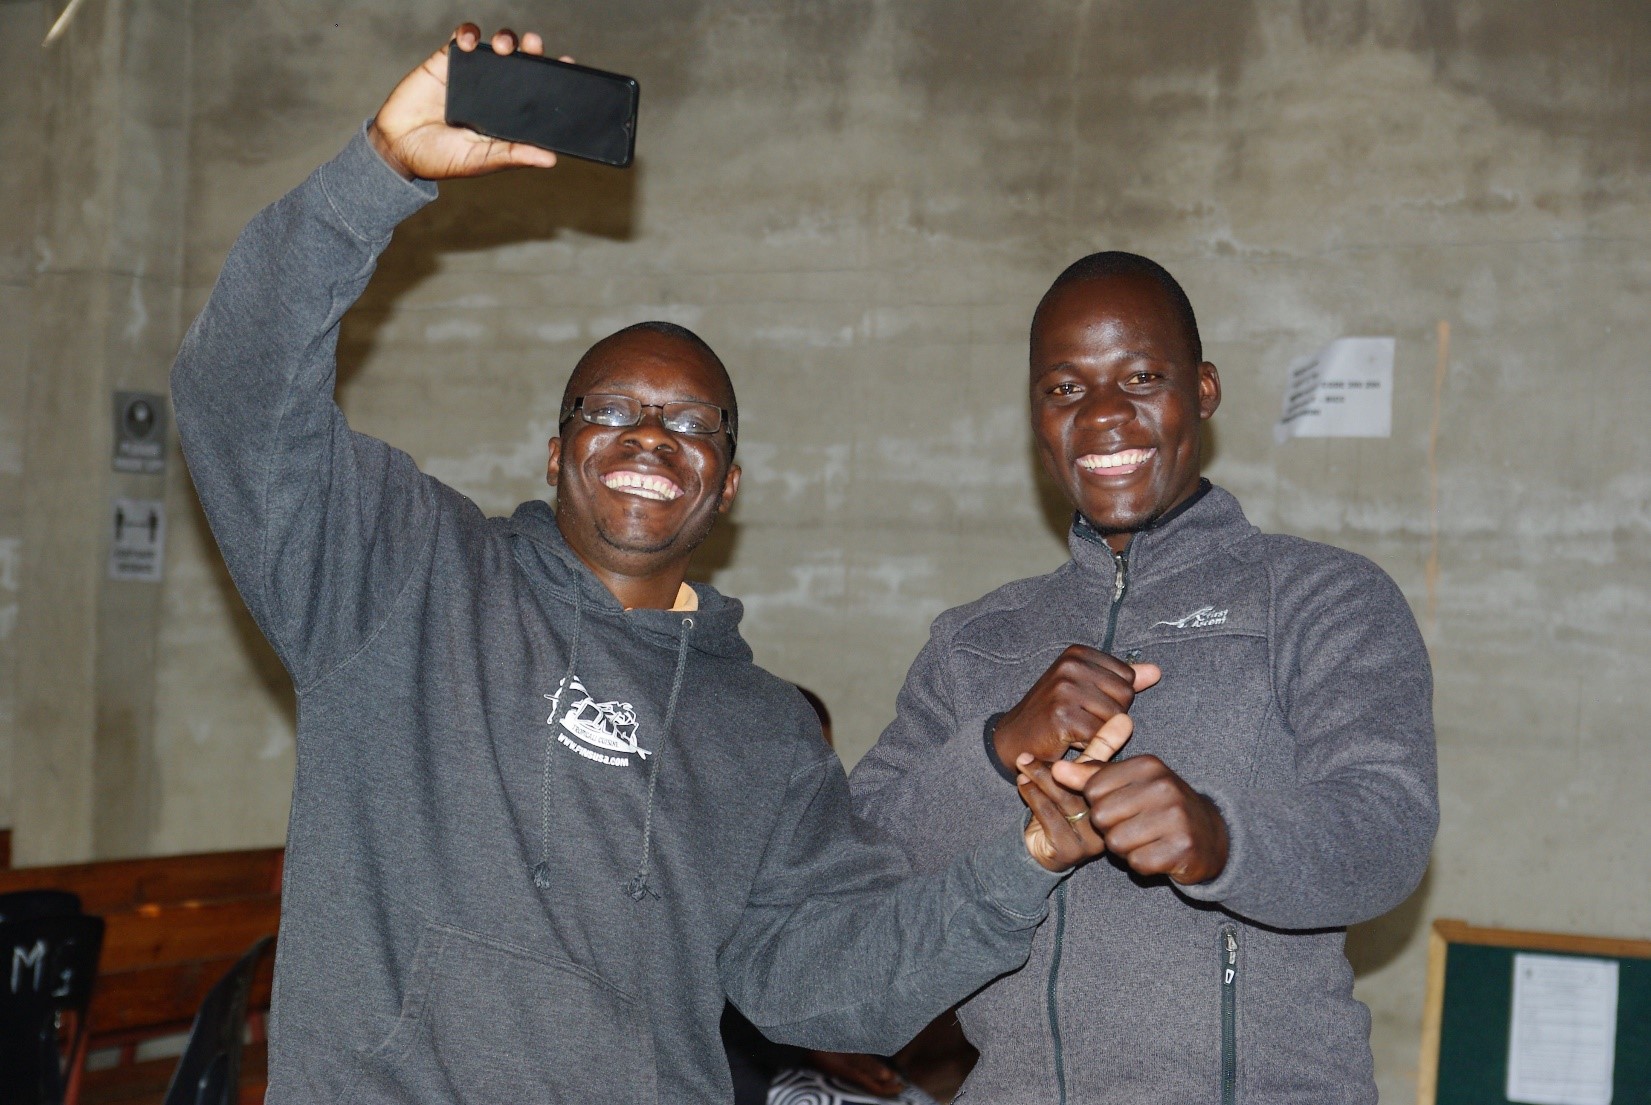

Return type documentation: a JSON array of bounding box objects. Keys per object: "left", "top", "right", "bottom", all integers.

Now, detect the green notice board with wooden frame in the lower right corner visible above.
[{"left": 1417, "top": 920, "right": 1651, "bottom": 1105}]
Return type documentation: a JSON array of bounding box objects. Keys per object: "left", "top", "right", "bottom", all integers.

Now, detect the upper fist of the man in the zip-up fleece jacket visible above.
[{"left": 992, "top": 644, "right": 1162, "bottom": 773}]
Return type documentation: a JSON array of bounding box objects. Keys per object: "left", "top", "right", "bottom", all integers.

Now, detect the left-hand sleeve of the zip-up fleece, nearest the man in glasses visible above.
[{"left": 850, "top": 613, "right": 1025, "bottom": 870}]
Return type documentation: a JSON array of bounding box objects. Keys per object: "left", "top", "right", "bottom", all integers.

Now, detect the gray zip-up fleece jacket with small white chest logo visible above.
[{"left": 850, "top": 489, "right": 1438, "bottom": 1105}]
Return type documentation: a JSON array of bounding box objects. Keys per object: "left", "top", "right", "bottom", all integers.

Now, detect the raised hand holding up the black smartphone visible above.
[{"left": 367, "top": 23, "right": 556, "bottom": 180}]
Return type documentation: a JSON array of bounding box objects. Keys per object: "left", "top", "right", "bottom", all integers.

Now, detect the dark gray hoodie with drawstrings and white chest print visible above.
[{"left": 173, "top": 135, "right": 1058, "bottom": 1105}]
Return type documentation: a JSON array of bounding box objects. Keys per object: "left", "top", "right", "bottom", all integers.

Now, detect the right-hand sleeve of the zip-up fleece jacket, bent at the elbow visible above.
[{"left": 1182, "top": 555, "right": 1438, "bottom": 928}]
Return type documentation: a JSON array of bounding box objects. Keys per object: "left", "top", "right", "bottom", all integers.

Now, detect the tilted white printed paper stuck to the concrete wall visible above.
[{"left": 1273, "top": 337, "right": 1393, "bottom": 443}]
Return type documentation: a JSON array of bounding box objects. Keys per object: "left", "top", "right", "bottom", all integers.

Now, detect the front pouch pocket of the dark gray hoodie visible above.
[{"left": 348, "top": 925, "right": 655, "bottom": 1105}]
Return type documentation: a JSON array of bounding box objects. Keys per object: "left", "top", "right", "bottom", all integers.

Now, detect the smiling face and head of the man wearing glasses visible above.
[{"left": 545, "top": 330, "right": 740, "bottom": 588}]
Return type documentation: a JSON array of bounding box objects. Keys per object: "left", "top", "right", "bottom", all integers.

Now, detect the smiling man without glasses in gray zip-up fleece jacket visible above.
[{"left": 850, "top": 253, "right": 1438, "bottom": 1105}]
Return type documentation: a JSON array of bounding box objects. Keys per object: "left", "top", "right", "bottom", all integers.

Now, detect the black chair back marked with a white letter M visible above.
[{"left": 0, "top": 895, "right": 104, "bottom": 1105}]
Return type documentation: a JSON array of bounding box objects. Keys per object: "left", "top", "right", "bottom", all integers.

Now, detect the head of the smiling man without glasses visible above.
[{"left": 1030, "top": 251, "right": 1222, "bottom": 550}]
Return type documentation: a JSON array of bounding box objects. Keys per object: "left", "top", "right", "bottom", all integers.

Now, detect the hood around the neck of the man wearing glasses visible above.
[{"left": 502, "top": 499, "right": 751, "bottom": 661}]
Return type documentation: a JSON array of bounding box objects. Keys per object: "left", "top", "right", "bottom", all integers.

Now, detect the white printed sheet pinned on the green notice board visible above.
[{"left": 1507, "top": 953, "right": 1616, "bottom": 1105}]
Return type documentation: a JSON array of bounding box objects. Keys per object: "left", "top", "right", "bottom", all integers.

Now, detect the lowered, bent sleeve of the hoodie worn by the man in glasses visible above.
[{"left": 718, "top": 739, "right": 1062, "bottom": 1054}]
